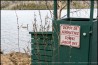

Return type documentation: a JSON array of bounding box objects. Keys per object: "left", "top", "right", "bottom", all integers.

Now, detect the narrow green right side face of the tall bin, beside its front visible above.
[{"left": 89, "top": 20, "right": 98, "bottom": 65}]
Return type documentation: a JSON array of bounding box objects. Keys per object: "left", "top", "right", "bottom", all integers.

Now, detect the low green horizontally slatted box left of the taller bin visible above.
[{"left": 29, "top": 32, "right": 53, "bottom": 65}]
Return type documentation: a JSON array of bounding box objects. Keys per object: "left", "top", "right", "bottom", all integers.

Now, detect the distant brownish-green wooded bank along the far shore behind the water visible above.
[{"left": 1, "top": 1, "right": 97, "bottom": 10}]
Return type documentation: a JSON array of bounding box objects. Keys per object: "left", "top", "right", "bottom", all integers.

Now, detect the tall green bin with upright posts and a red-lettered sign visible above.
[{"left": 53, "top": 0, "right": 98, "bottom": 65}]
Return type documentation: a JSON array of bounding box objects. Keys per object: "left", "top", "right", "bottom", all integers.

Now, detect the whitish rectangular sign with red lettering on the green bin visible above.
[{"left": 60, "top": 24, "right": 80, "bottom": 48}]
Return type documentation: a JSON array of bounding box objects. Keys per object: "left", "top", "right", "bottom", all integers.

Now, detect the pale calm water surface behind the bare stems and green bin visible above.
[{"left": 1, "top": 9, "right": 97, "bottom": 53}]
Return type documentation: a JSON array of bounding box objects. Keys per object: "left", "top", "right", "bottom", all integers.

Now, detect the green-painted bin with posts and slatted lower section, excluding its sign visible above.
[{"left": 30, "top": 0, "right": 98, "bottom": 65}]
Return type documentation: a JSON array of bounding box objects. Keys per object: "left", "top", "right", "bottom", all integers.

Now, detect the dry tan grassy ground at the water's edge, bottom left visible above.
[{"left": 0, "top": 52, "right": 31, "bottom": 65}]
